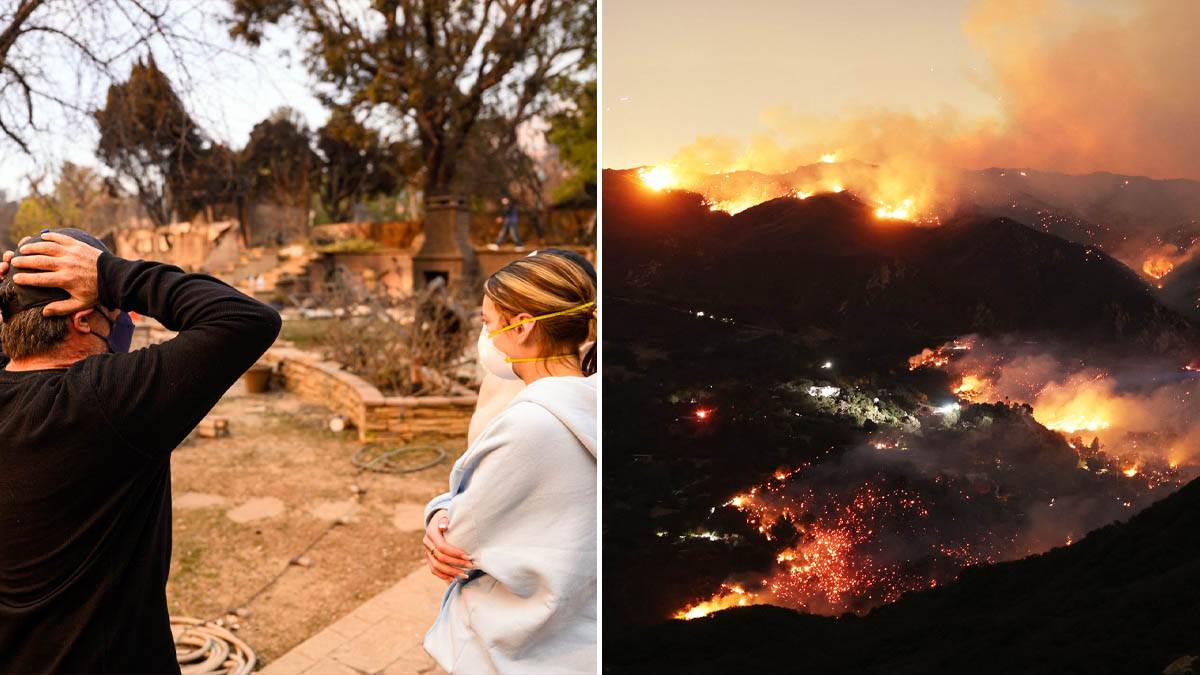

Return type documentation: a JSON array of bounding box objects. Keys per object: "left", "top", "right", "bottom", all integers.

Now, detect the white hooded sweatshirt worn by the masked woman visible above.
[{"left": 425, "top": 375, "right": 598, "bottom": 675}]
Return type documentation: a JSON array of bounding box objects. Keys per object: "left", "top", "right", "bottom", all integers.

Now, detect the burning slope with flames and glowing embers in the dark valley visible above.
[{"left": 674, "top": 335, "right": 1200, "bottom": 620}]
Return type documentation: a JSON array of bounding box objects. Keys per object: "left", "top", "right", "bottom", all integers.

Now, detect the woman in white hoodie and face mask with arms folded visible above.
[{"left": 425, "top": 256, "right": 596, "bottom": 675}]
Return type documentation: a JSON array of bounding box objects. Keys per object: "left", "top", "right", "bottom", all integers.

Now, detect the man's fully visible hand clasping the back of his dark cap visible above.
[{"left": 11, "top": 232, "right": 101, "bottom": 316}]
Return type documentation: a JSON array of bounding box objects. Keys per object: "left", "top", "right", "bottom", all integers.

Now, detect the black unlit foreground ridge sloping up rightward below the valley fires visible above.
[{"left": 605, "top": 473, "right": 1200, "bottom": 674}]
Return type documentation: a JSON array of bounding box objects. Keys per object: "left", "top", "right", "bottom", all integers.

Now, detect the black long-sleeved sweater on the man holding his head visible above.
[{"left": 0, "top": 253, "right": 280, "bottom": 673}]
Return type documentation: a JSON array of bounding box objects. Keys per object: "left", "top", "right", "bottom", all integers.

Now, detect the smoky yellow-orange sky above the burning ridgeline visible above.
[{"left": 601, "top": 0, "right": 1200, "bottom": 179}]
